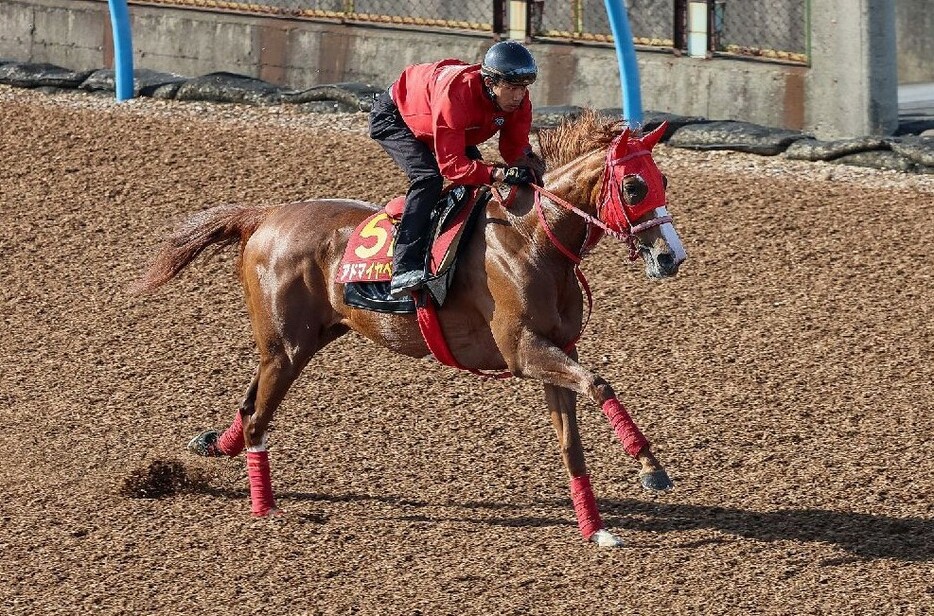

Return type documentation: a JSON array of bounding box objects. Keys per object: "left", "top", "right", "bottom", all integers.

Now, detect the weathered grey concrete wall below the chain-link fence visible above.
[{"left": 0, "top": 0, "right": 927, "bottom": 138}]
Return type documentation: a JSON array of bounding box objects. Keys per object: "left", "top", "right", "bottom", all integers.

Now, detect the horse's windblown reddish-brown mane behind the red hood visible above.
[{"left": 538, "top": 109, "right": 625, "bottom": 169}]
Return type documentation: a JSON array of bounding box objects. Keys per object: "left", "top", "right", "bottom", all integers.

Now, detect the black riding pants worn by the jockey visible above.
[{"left": 370, "top": 92, "right": 481, "bottom": 274}]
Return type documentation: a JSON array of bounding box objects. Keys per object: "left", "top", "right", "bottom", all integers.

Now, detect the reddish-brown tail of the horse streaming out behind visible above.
[{"left": 130, "top": 205, "right": 276, "bottom": 294}]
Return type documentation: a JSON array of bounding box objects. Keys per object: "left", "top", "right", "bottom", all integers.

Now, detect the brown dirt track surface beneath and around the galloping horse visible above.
[{"left": 0, "top": 89, "right": 934, "bottom": 615}]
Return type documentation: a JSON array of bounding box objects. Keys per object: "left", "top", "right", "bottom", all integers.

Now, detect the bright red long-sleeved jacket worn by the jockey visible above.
[{"left": 390, "top": 59, "right": 532, "bottom": 184}]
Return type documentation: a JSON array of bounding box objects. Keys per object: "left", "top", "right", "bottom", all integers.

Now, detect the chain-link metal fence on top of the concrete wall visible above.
[{"left": 133, "top": 0, "right": 809, "bottom": 63}]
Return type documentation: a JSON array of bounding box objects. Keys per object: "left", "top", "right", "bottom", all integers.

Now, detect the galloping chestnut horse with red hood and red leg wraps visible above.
[{"left": 133, "top": 111, "right": 685, "bottom": 546}]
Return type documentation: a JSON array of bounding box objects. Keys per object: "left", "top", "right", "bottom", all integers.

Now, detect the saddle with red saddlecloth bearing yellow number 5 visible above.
[{"left": 336, "top": 186, "right": 491, "bottom": 314}]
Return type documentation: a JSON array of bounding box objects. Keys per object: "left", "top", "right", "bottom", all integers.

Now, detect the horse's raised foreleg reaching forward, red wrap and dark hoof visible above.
[{"left": 510, "top": 334, "right": 672, "bottom": 491}]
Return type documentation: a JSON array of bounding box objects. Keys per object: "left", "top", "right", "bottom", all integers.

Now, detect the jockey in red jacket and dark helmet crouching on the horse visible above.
[{"left": 370, "top": 41, "right": 544, "bottom": 298}]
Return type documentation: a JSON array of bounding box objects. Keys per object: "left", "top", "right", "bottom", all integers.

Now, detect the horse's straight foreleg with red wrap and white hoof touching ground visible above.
[{"left": 545, "top": 383, "right": 622, "bottom": 547}]
